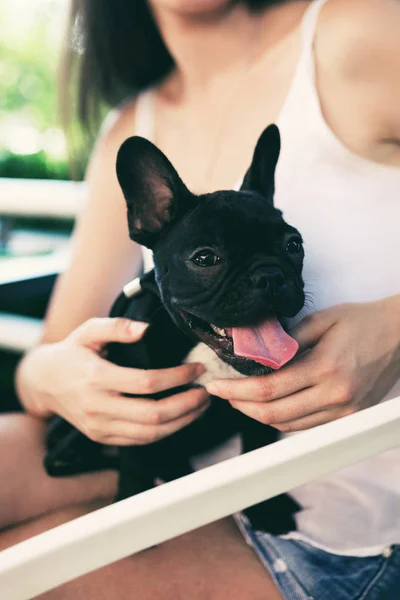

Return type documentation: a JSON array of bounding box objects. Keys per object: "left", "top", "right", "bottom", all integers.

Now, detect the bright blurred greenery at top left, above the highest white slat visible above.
[{"left": 0, "top": 0, "right": 86, "bottom": 179}]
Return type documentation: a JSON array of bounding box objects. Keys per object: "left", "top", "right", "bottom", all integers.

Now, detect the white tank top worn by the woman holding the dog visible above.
[{"left": 135, "top": 0, "right": 400, "bottom": 556}]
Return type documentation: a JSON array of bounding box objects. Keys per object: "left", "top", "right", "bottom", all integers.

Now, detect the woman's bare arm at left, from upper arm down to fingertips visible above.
[{"left": 16, "top": 101, "right": 208, "bottom": 434}]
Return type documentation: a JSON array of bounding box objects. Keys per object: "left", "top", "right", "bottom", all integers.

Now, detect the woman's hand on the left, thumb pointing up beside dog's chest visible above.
[{"left": 17, "top": 319, "right": 208, "bottom": 446}]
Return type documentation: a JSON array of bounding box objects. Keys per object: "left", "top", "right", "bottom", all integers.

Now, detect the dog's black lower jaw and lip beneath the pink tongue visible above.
[{"left": 179, "top": 311, "right": 273, "bottom": 376}]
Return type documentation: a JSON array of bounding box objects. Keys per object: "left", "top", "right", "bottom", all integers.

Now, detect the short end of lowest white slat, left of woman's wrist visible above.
[{"left": 0, "top": 313, "right": 43, "bottom": 352}]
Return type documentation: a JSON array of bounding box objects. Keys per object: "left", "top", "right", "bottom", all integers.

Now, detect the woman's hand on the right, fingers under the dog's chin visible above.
[{"left": 207, "top": 296, "right": 400, "bottom": 432}]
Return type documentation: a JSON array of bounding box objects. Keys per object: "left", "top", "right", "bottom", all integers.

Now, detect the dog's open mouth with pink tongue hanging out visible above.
[{"left": 181, "top": 312, "right": 299, "bottom": 369}]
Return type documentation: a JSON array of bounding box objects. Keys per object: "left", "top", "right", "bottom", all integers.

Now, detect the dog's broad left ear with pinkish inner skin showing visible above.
[{"left": 117, "top": 136, "right": 193, "bottom": 248}]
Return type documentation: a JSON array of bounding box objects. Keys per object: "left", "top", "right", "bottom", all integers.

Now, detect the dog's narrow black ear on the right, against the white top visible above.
[{"left": 240, "top": 125, "right": 281, "bottom": 204}]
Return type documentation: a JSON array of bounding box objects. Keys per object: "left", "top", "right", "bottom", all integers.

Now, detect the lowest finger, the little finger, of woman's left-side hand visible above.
[{"left": 103, "top": 405, "right": 208, "bottom": 445}]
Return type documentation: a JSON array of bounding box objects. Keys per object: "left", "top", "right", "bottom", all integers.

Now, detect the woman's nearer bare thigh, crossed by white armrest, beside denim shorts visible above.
[{"left": 0, "top": 505, "right": 281, "bottom": 600}]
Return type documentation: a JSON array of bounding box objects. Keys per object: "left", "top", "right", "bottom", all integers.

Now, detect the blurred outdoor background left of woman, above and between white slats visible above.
[{"left": 0, "top": 0, "right": 76, "bottom": 404}]
